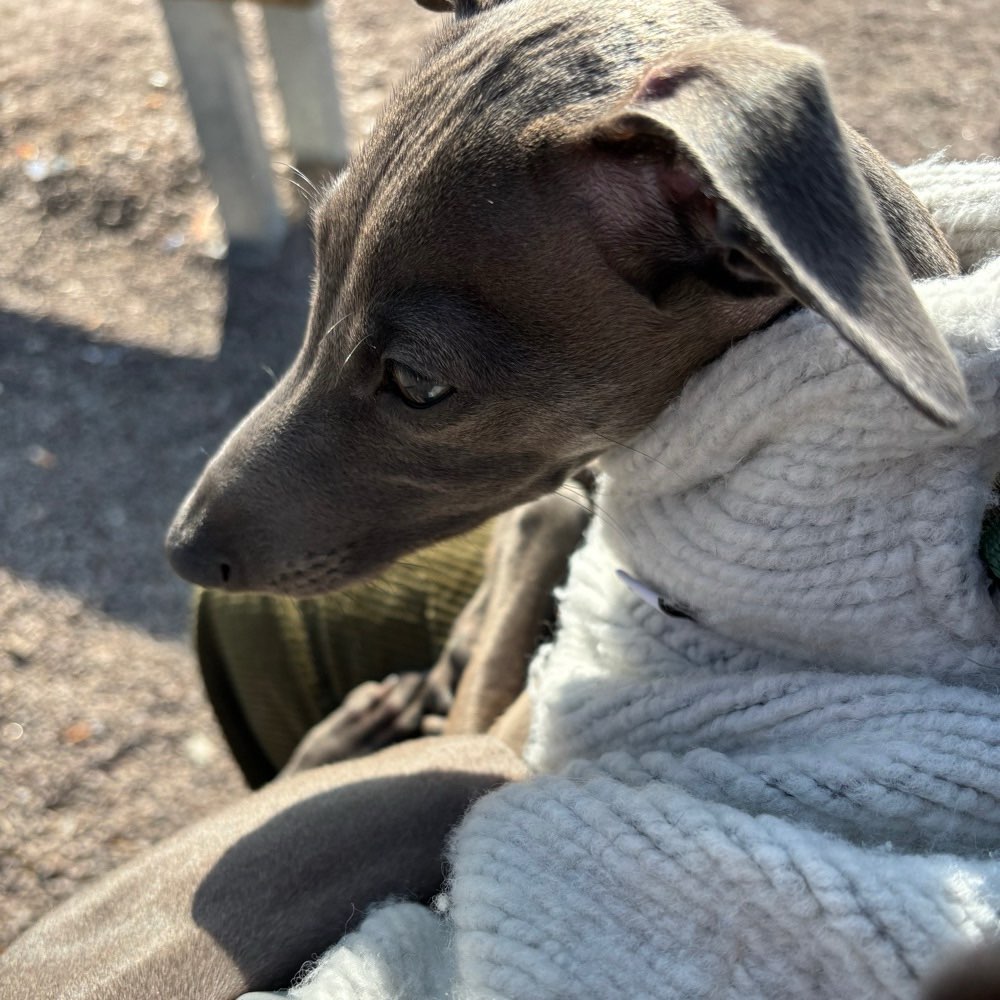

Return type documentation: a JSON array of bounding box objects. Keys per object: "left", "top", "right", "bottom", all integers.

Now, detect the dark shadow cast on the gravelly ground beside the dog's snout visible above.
[{"left": 0, "top": 228, "right": 312, "bottom": 635}]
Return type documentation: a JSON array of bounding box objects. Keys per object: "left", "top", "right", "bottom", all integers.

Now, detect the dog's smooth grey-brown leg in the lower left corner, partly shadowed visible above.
[{"left": 0, "top": 736, "right": 527, "bottom": 1000}]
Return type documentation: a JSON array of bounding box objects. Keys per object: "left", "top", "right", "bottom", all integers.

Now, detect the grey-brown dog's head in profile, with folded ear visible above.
[{"left": 167, "top": 0, "right": 966, "bottom": 595}]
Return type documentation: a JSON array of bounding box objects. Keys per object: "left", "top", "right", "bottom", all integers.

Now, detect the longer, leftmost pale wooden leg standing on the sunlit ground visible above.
[{"left": 162, "top": 0, "right": 286, "bottom": 258}]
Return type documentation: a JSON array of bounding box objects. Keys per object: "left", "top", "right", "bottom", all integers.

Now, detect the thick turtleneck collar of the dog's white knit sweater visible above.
[{"left": 596, "top": 274, "right": 1000, "bottom": 682}]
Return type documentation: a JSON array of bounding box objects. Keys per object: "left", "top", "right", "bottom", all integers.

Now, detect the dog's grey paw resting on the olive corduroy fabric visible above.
[{"left": 281, "top": 671, "right": 452, "bottom": 775}]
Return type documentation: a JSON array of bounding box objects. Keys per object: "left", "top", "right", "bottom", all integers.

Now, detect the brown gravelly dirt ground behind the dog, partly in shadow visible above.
[{"left": 0, "top": 0, "right": 1000, "bottom": 949}]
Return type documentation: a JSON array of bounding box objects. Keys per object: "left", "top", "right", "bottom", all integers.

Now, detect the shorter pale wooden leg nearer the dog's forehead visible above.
[{"left": 264, "top": 2, "right": 347, "bottom": 173}]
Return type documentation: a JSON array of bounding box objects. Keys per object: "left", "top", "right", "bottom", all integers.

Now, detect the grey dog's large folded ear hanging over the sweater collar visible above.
[{"left": 584, "top": 32, "right": 968, "bottom": 426}]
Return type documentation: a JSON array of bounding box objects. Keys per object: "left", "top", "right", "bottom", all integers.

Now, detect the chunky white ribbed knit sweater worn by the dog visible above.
[{"left": 272, "top": 161, "right": 1000, "bottom": 1000}]
